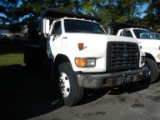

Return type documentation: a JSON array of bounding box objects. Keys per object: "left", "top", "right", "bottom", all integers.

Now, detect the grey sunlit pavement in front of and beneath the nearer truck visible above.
[{"left": 30, "top": 80, "right": 160, "bottom": 120}]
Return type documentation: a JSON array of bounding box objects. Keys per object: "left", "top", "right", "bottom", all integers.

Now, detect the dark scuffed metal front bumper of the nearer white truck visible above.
[{"left": 77, "top": 66, "right": 149, "bottom": 88}]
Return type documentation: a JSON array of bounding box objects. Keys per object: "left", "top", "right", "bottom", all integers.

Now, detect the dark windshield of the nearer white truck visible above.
[{"left": 64, "top": 19, "right": 106, "bottom": 34}]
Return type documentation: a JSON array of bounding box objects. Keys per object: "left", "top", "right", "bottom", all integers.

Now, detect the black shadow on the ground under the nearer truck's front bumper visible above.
[{"left": 80, "top": 82, "right": 150, "bottom": 105}]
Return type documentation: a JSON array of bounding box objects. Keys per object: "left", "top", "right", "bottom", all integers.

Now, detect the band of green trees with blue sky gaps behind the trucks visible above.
[{"left": 0, "top": 0, "right": 155, "bottom": 35}]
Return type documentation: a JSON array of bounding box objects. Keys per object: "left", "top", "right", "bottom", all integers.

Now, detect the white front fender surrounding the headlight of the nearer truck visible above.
[{"left": 57, "top": 49, "right": 106, "bottom": 72}]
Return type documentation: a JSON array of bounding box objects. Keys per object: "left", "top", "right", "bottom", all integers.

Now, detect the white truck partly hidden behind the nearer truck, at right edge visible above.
[{"left": 117, "top": 28, "right": 160, "bottom": 83}]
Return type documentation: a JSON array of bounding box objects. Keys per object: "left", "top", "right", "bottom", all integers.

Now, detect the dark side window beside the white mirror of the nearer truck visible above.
[{"left": 52, "top": 21, "right": 62, "bottom": 35}]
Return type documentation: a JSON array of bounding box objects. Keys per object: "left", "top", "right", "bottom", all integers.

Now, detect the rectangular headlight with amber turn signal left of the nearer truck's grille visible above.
[{"left": 75, "top": 58, "right": 96, "bottom": 67}]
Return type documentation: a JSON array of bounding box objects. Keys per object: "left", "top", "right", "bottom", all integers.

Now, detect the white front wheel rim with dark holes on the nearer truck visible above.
[{"left": 59, "top": 72, "right": 70, "bottom": 97}]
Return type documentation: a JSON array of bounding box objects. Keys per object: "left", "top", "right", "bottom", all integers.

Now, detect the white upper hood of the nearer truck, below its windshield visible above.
[{"left": 62, "top": 33, "right": 137, "bottom": 51}]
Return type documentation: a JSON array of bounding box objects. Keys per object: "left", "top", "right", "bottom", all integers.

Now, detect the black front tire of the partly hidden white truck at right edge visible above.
[{"left": 146, "top": 58, "right": 159, "bottom": 83}]
